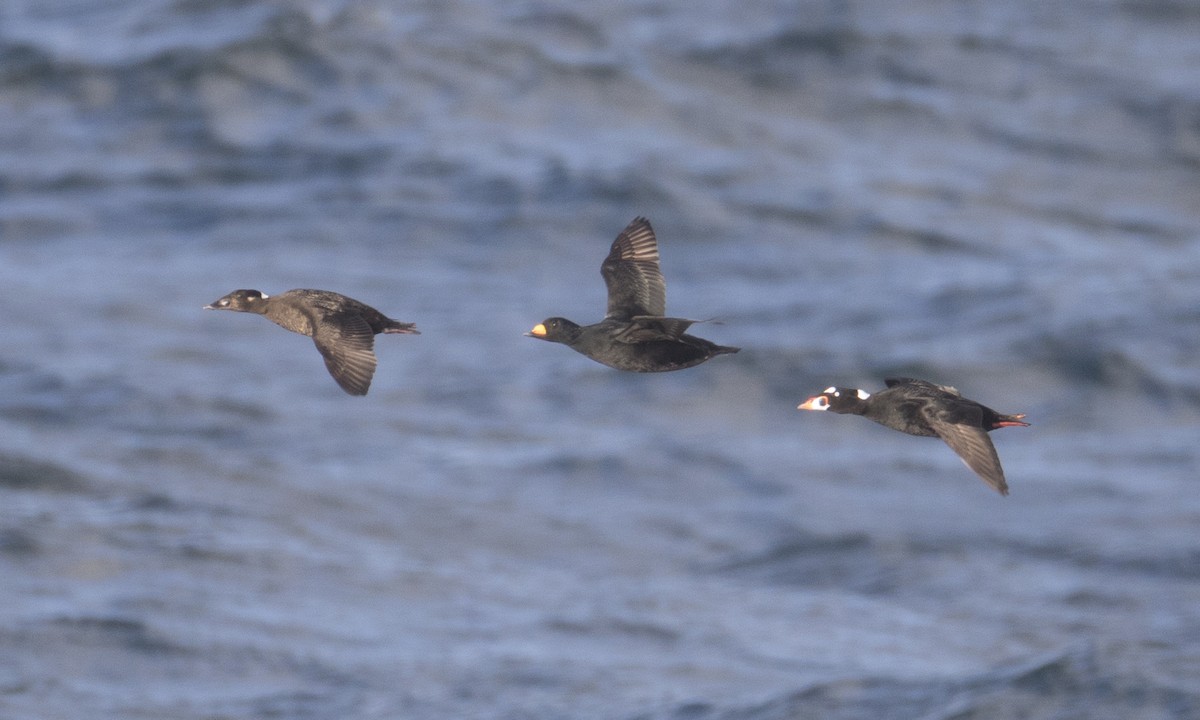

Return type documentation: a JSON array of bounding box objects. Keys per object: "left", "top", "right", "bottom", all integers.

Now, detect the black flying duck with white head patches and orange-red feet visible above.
[{"left": 799, "top": 378, "right": 1028, "bottom": 494}]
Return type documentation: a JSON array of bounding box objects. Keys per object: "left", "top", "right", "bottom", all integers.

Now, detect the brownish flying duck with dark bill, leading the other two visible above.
[{"left": 204, "top": 289, "right": 420, "bottom": 395}]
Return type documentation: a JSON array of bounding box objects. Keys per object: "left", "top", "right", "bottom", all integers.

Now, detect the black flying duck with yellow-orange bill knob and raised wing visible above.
[{"left": 526, "top": 217, "right": 740, "bottom": 372}]
